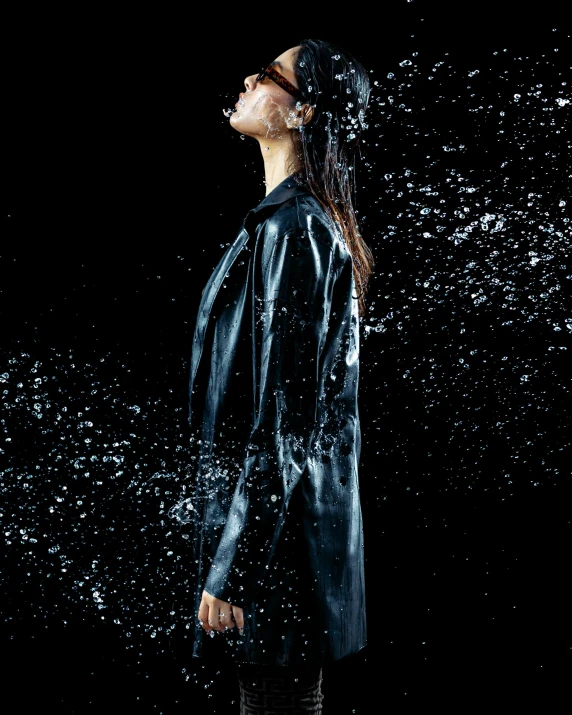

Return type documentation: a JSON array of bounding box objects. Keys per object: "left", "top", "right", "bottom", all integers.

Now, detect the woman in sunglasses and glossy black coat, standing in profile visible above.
[{"left": 173, "top": 40, "right": 373, "bottom": 713}]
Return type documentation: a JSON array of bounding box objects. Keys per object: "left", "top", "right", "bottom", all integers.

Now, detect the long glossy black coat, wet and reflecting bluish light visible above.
[{"left": 172, "top": 178, "right": 366, "bottom": 665}]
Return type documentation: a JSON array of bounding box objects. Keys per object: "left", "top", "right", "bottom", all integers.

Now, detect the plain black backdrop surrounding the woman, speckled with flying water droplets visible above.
[{"left": 0, "top": 1, "right": 572, "bottom": 715}]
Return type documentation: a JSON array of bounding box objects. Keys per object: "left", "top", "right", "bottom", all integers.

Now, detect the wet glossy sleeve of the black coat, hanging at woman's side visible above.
[{"left": 204, "top": 224, "right": 334, "bottom": 606}]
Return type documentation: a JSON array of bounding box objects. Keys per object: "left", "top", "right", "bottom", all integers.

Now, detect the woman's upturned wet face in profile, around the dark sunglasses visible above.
[{"left": 230, "top": 47, "right": 300, "bottom": 142}]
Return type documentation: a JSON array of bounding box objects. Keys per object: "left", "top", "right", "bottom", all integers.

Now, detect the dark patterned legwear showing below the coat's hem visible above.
[{"left": 238, "top": 664, "right": 323, "bottom": 715}]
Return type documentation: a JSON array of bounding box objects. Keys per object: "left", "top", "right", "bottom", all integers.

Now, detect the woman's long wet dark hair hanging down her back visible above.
[{"left": 294, "top": 40, "right": 375, "bottom": 315}]
